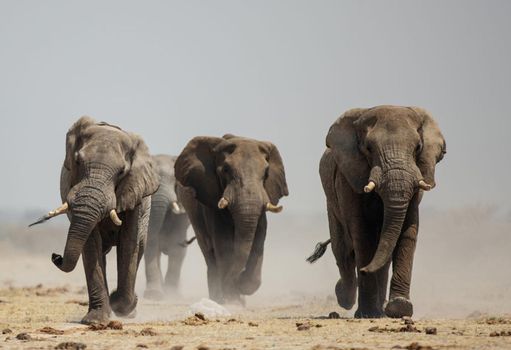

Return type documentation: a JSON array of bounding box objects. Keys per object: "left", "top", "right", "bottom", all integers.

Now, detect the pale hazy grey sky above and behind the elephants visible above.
[{"left": 0, "top": 0, "right": 511, "bottom": 212}]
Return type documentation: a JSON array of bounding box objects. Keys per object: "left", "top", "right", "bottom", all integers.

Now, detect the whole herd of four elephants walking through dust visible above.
[{"left": 34, "top": 106, "right": 446, "bottom": 323}]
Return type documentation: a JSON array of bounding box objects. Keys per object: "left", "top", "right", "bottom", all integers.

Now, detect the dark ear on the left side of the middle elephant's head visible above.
[{"left": 174, "top": 136, "right": 225, "bottom": 208}]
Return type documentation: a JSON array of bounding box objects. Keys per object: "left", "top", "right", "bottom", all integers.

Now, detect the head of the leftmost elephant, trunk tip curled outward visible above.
[{"left": 48, "top": 117, "right": 158, "bottom": 272}]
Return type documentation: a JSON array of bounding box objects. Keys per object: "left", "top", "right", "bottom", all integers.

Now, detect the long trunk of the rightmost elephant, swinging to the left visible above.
[{"left": 360, "top": 170, "right": 417, "bottom": 274}]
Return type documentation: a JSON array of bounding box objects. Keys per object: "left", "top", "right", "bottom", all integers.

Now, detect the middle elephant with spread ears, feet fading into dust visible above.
[{"left": 175, "top": 134, "right": 289, "bottom": 305}]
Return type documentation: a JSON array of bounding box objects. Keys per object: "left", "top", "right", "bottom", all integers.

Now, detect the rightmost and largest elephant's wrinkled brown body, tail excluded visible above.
[{"left": 319, "top": 106, "right": 445, "bottom": 318}]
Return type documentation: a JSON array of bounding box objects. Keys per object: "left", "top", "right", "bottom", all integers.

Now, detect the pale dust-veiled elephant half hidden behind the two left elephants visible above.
[{"left": 144, "top": 155, "right": 190, "bottom": 300}]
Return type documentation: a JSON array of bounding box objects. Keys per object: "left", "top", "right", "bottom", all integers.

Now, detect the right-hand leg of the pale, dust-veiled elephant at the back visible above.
[{"left": 165, "top": 214, "right": 189, "bottom": 294}]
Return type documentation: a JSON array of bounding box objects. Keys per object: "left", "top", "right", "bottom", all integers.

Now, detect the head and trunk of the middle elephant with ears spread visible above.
[{"left": 175, "top": 135, "right": 288, "bottom": 294}]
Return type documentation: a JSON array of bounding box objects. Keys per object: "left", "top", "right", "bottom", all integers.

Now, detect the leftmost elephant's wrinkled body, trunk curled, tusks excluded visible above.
[{"left": 52, "top": 117, "right": 158, "bottom": 323}]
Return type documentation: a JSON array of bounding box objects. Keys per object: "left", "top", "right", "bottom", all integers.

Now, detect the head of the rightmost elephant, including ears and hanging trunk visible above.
[{"left": 326, "top": 106, "right": 446, "bottom": 273}]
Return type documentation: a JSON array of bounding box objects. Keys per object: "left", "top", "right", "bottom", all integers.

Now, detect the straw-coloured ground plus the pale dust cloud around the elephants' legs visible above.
[{"left": 0, "top": 208, "right": 511, "bottom": 350}]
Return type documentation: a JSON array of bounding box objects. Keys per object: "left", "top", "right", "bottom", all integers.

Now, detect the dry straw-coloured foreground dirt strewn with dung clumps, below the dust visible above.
[{"left": 0, "top": 285, "right": 511, "bottom": 350}]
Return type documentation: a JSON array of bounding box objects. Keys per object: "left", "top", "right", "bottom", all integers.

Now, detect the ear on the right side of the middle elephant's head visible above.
[{"left": 264, "top": 142, "right": 289, "bottom": 205}]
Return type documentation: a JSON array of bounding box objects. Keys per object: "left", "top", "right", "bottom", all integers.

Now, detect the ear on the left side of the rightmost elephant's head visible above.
[{"left": 326, "top": 108, "right": 370, "bottom": 193}]
